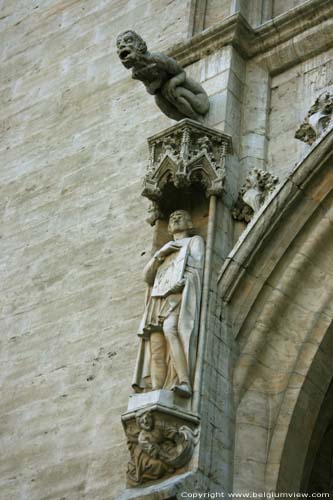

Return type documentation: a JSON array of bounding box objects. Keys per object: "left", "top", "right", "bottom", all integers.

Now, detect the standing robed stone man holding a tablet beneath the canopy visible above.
[{"left": 133, "top": 210, "right": 205, "bottom": 398}]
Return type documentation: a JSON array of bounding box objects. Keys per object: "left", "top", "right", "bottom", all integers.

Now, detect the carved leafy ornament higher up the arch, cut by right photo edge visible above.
[{"left": 295, "top": 92, "right": 333, "bottom": 146}]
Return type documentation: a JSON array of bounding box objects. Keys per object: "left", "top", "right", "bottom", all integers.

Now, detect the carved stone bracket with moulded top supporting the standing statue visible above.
[{"left": 122, "top": 398, "right": 200, "bottom": 488}]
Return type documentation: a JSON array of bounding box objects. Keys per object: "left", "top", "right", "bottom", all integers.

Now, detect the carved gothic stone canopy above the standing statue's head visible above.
[{"left": 142, "top": 118, "right": 232, "bottom": 210}]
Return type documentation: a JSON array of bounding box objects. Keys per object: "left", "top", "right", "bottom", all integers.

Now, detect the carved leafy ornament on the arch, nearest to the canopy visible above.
[{"left": 232, "top": 168, "right": 279, "bottom": 222}]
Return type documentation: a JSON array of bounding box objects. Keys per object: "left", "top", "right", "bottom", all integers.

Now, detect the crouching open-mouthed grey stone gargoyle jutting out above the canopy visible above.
[{"left": 117, "top": 30, "right": 209, "bottom": 121}]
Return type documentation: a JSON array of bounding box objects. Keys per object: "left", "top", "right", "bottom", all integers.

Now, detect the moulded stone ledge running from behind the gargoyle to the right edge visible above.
[{"left": 168, "top": 0, "right": 333, "bottom": 74}]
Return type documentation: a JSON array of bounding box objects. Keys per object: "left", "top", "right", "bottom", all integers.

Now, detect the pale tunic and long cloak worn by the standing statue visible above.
[{"left": 132, "top": 236, "right": 205, "bottom": 392}]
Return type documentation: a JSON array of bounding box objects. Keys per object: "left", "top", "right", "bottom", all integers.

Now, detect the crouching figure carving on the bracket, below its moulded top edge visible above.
[{"left": 124, "top": 410, "right": 198, "bottom": 487}]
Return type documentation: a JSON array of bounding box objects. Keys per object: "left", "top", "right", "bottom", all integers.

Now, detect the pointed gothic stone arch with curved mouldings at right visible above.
[{"left": 220, "top": 130, "right": 333, "bottom": 492}]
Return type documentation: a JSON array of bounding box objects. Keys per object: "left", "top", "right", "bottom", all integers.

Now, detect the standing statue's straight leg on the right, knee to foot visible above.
[{"left": 163, "top": 313, "right": 190, "bottom": 387}]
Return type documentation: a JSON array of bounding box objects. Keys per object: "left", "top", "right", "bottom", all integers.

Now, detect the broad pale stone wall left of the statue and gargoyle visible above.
[{"left": 0, "top": 0, "right": 191, "bottom": 500}]
